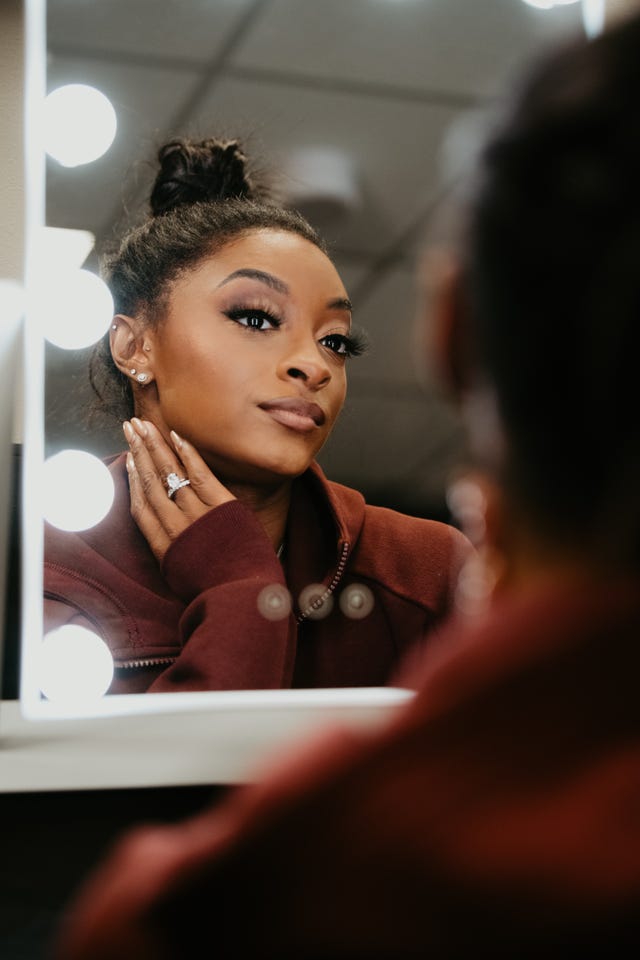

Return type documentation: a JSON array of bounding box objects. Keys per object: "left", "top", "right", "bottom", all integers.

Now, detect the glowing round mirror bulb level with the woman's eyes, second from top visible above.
[{"left": 33, "top": 270, "right": 113, "bottom": 350}]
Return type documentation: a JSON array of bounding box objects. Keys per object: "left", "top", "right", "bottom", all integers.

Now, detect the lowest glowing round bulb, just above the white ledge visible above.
[{"left": 37, "top": 624, "right": 113, "bottom": 706}]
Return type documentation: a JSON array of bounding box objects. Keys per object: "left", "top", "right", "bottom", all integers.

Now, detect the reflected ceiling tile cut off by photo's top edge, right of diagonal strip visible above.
[{"left": 233, "top": 0, "right": 582, "bottom": 97}]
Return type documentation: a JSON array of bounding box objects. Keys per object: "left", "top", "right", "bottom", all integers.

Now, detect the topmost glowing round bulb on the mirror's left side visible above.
[{"left": 44, "top": 83, "right": 118, "bottom": 167}]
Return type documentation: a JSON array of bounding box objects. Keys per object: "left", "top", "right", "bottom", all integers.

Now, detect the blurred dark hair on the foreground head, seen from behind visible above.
[{"left": 464, "top": 18, "right": 640, "bottom": 565}]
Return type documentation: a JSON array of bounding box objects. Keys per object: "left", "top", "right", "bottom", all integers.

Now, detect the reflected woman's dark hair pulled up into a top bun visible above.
[{"left": 89, "top": 138, "right": 327, "bottom": 420}]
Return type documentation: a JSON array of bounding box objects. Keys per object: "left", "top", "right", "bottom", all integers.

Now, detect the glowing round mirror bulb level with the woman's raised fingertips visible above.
[{"left": 43, "top": 450, "right": 114, "bottom": 530}]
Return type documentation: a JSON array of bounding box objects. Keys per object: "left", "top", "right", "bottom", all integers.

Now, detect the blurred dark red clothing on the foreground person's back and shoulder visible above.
[{"left": 55, "top": 581, "right": 640, "bottom": 960}]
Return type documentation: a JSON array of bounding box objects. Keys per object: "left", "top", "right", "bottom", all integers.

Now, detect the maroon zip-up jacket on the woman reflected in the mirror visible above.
[{"left": 44, "top": 456, "right": 470, "bottom": 693}]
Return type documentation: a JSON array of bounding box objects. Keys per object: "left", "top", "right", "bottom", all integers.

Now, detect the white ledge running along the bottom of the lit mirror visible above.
[{"left": 0, "top": 688, "right": 412, "bottom": 793}]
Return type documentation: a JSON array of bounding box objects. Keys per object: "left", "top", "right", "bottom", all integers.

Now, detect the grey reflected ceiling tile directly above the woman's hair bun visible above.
[{"left": 186, "top": 79, "right": 459, "bottom": 253}]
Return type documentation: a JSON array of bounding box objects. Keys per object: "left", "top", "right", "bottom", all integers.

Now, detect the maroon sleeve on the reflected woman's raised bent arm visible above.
[{"left": 149, "top": 500, "right": 296, "bottom": 692}]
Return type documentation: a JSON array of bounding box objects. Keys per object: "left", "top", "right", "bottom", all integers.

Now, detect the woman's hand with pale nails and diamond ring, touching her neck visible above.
[{"left": 123, "top": 417, "right": 235, "bottom": 562}]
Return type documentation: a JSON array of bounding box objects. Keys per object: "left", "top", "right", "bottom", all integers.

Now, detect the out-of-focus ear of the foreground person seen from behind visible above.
[{"left": 424, "top": 255, "right": 473, "bottom": 399}]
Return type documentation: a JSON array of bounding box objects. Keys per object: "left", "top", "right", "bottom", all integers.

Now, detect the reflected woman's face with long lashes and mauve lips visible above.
[{"left": 143, "top": 230, "right": 358, "bottom": 482}]
